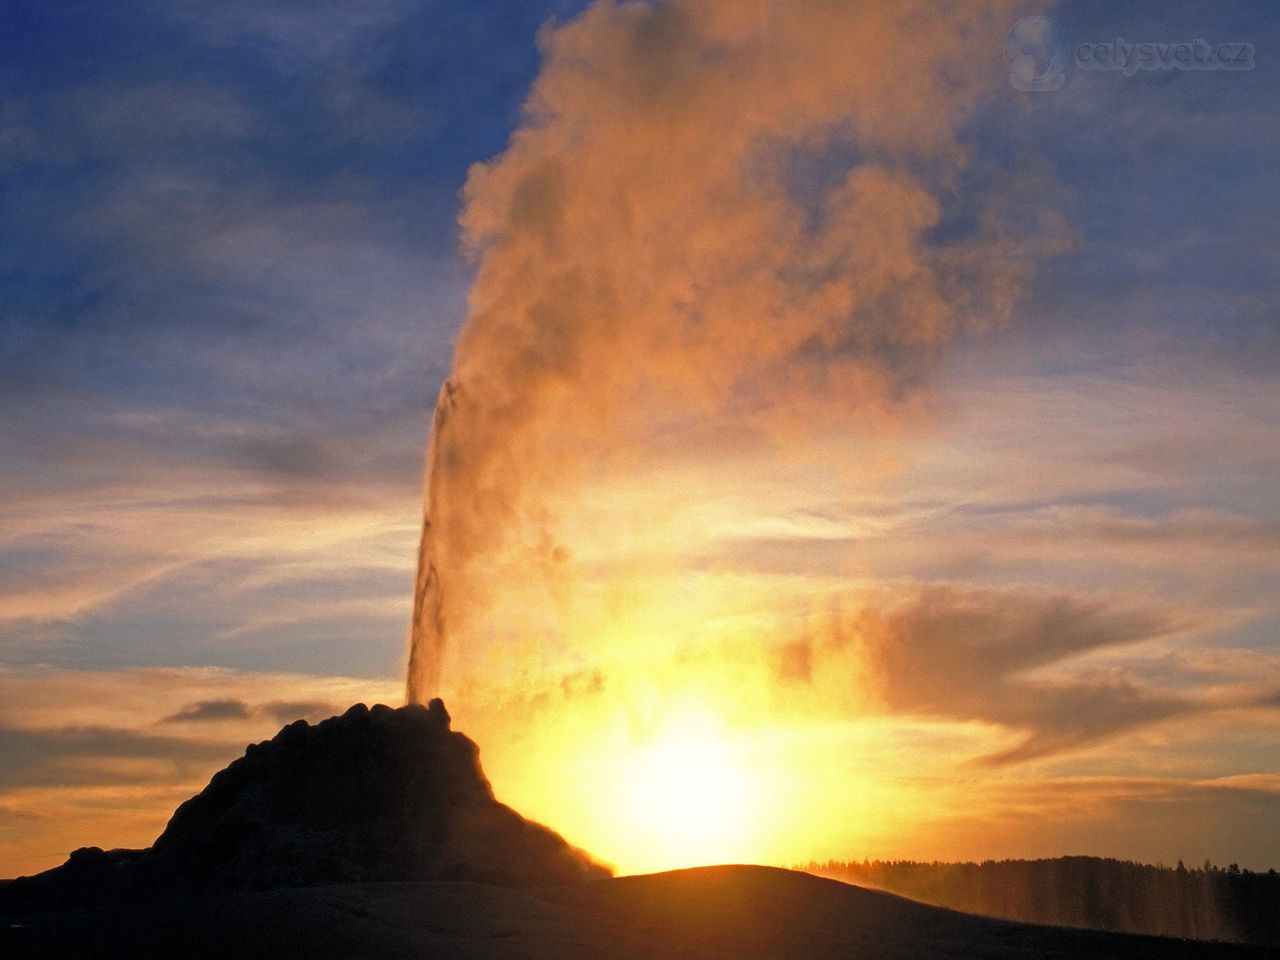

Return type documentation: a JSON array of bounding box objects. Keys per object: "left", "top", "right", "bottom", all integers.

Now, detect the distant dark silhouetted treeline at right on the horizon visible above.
[{"left": 803, "top": 856, "right": 1280, "bottom": 945}]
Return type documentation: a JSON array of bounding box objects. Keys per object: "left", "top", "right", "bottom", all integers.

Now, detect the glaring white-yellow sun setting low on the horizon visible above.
[{"left": 616, "top": 718, "right": 760, "bottom": 870}]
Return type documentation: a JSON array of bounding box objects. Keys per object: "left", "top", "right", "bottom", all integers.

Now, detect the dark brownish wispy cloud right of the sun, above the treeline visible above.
[{"left": 762, "top": 585, "right": 1221, "bottom": 765}]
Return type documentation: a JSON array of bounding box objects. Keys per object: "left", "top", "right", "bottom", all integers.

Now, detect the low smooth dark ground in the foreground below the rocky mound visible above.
[{"left": 0, "top": 867, "right": 1275, "bottom": 960}]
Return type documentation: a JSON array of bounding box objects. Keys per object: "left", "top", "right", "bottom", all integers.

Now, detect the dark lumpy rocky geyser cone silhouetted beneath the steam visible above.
[{"left": 0, "top": 700, "right": 609, "bottom": 904}]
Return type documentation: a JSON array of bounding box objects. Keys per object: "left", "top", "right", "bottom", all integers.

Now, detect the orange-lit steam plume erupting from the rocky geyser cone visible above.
[{"left": 408, "top": 0, "right": 1052, "bottom": 700}]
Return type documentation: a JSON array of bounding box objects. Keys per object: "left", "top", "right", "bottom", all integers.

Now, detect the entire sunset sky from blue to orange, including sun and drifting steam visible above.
[{"left": 0, "top": 0, "right": 1280, "bottom": 876}]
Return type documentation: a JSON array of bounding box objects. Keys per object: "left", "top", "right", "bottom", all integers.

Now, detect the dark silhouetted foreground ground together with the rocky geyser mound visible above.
[{"left": 0, "top": 700, "right": 1274, "bottom": 960}]
